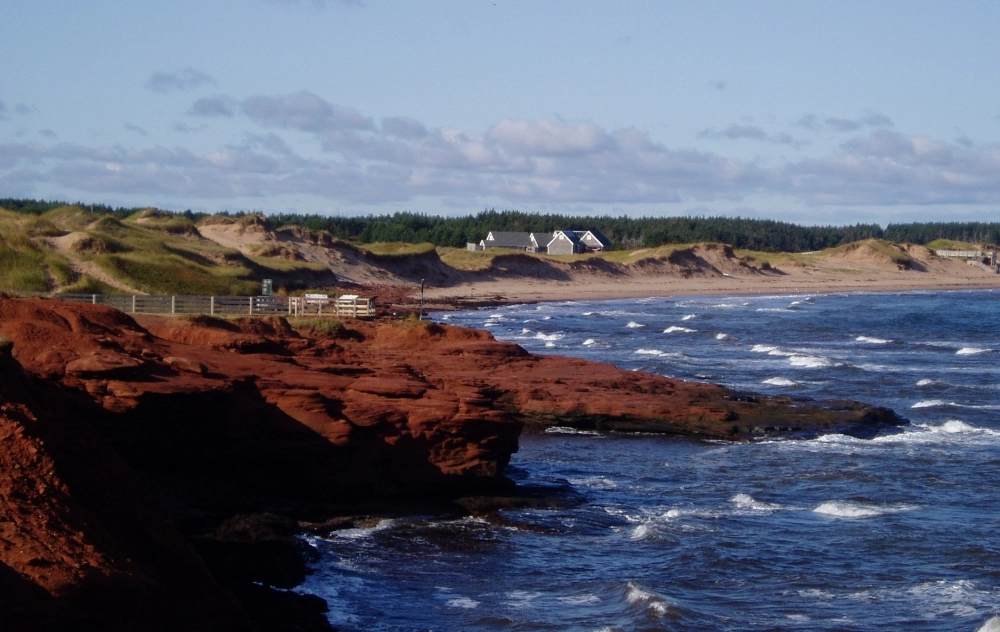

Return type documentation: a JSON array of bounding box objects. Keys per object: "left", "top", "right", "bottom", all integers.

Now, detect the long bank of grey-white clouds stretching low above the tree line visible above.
[{"left": 0, "top": 91, "right": 1000, "bottom": 211}]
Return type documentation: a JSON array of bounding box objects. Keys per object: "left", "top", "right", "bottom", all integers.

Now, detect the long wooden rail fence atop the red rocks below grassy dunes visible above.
[{"left": 44, "top": 294, "right": 375, "bottom": 318}]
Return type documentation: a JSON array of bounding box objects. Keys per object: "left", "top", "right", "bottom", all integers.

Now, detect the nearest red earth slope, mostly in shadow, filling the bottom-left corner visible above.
[{"left": 0, "top": 346, "right": 251, "bottom": 630}]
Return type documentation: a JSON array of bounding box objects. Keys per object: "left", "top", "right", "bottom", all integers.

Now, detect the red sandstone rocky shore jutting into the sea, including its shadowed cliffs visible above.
[{"left": 0, "top": 297, "right": 905, "bottom": 630}]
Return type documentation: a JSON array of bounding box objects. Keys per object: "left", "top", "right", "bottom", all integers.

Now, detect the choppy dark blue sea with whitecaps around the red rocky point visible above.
[{"left": 299, "top": 291, "right": 1000, "bottom": 632}]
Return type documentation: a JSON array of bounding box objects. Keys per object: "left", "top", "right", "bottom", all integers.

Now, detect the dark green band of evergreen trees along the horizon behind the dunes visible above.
[{"left": 0, "top": 198, "right": 1000, "bottom": 252}]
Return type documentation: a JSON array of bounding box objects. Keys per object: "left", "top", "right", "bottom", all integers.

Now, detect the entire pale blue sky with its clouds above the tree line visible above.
[{"left": 0, "top": 0, "right": 1000, "bottom": 226}]
